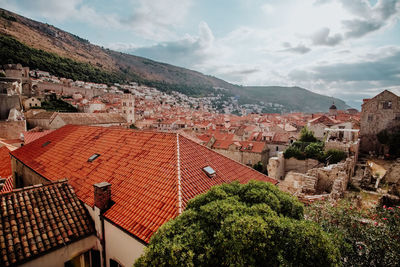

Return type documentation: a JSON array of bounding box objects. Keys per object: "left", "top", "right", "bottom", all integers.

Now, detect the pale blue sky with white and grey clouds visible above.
[{"left": 0, "top": 0, "right": 400, "bottom": 108}]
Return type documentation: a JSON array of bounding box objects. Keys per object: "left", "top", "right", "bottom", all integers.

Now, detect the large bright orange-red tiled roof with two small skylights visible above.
[{"left": 12, "top": 125, "right": 277, "bottom": 245}]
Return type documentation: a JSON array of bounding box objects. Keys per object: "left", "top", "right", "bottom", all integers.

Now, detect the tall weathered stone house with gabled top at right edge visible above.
[{"left": 360, "top": 90, "right": 400, "bottom": 154}]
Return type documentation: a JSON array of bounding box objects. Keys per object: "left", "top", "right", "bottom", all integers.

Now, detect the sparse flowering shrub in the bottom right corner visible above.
[{"left": 306, "top": 201, "right": 400, "bottom": 266}]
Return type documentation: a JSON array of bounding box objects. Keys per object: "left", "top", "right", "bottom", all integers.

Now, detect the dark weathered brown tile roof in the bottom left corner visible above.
[{"left": 0, "top": 180, "right": 94, "bottom": 266}]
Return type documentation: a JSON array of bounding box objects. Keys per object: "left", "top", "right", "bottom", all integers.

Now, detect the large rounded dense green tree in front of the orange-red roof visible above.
[{"left": 135, "top": 182, "right": 339, "bottom": 266}]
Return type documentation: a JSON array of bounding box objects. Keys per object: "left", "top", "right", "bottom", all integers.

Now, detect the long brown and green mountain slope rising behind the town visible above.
[{"left": 0, "top": 9, "right": 348, "bottom": 112}]
